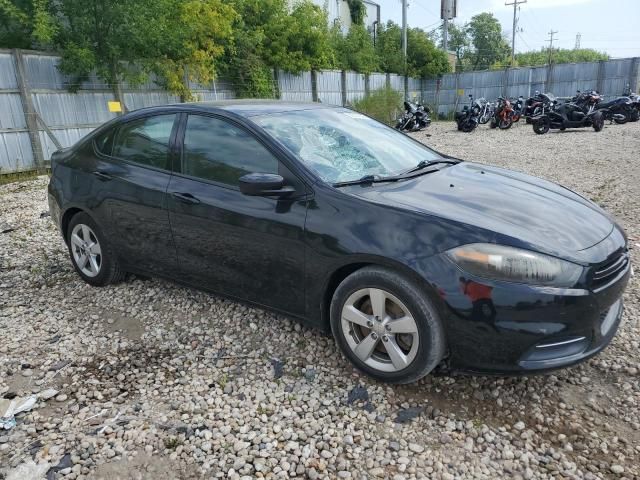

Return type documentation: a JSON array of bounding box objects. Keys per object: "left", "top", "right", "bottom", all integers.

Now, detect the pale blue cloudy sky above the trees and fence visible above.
[{"left": 374, "top": 0, "right": 640, "bottom": 58}]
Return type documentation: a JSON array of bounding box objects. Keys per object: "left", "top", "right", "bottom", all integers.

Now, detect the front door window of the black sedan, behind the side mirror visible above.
[{"left": 182, "top": 115, "right": 278, "bottom": 186}]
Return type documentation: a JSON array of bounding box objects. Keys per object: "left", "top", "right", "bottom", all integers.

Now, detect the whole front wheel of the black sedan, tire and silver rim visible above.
[{"left": 330, "top": 267, "right": 445, "bottom": 383}]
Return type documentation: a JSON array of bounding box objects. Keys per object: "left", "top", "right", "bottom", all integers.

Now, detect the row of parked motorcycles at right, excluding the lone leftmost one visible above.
[{"left": 455, "top": 90, "right": 640, "bottom": 135}]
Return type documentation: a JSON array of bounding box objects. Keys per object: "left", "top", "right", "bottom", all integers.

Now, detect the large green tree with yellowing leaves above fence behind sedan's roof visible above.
[{"left": 50, "top": 0, "right": 235, "bottom": 99}]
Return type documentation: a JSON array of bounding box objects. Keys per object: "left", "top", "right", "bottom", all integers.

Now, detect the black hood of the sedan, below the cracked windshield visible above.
[{"left": 350, "top": 162, "right": 614, "bottom": 253}]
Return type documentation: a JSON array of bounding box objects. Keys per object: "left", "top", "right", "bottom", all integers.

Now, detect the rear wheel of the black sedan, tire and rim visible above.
[{"left": 67, "top": 212, "right": 125, "bottom": 287}]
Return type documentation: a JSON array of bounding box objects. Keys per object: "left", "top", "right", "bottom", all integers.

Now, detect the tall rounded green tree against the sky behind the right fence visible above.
[{"left": 466, "top": 12, "right": 511, "bottom": 70}]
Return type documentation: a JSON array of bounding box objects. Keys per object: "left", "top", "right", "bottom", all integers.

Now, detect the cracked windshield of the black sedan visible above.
[{"left": 252, "top": 108, "right": 440, "bottom": 183}]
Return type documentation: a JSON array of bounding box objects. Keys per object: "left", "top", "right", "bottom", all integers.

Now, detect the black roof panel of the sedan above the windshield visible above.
[{"left": 176, "top": 99, "right": 340, "bottom": 117}]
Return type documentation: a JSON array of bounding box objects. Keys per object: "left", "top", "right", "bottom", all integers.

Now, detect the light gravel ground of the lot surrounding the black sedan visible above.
[{"left": 0, "top": 123, "right": 640, "bottom": 479}]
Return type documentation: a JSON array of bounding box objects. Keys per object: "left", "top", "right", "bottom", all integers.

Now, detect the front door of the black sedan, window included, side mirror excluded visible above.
[{"left": 167, "top": 114, "right": 307, "bottom": 315}]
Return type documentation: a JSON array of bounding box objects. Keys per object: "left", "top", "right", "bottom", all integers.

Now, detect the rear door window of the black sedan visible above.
[{"left": 113, "top": 114, "right": 176, "bottom": 169}]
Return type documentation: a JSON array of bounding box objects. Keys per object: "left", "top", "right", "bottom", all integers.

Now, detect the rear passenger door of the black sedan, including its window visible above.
[{"left": 92, "top": 113, "right": 178, "bottom": 276}]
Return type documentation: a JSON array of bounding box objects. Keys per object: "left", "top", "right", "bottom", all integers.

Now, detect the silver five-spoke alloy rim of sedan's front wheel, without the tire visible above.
[{"left": 340, "top": 288, "right": 419, "bottom": 372}]
